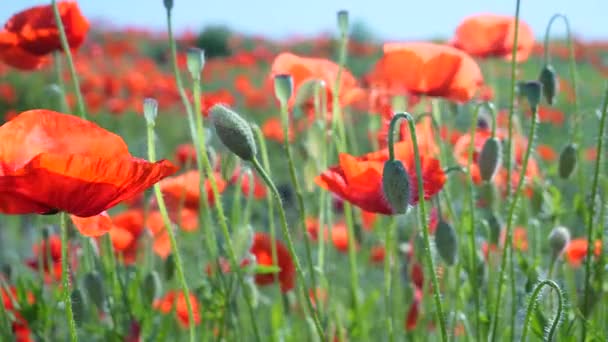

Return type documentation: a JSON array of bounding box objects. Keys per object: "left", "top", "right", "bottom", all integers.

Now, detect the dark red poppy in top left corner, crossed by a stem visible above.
[{"left": 2, "top": 1, "right": 89, "bottom": 56}]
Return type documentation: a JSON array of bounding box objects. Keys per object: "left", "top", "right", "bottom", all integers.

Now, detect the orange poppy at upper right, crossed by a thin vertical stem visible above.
[{"left": 452, "top": 14, "right": 534, "bottom": 62}]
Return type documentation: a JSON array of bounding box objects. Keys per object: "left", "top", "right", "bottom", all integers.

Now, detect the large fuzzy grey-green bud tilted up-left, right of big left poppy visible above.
[{"left": 211, "top": 104, "right": 257, "bottom": 161}]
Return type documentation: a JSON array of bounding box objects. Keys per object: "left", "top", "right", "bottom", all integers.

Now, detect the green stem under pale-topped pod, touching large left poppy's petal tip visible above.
[{"left": 147, "top": 123, "right": 196, "bottom": 342}]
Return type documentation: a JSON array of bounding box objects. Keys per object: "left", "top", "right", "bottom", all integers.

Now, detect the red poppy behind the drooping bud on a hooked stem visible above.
[{"left": 315, "top": 151, "right": 446, "bottom": 215}]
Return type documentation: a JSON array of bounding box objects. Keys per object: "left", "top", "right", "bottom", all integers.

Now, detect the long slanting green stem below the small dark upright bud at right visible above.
[{"left": 490, "top": 99, "right": 538, "bottom": 341}]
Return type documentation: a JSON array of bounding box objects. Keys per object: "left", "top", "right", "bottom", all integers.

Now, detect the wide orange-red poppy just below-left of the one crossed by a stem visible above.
[{"left": 367, "top": 43, "right": 483, "bottom": 102}]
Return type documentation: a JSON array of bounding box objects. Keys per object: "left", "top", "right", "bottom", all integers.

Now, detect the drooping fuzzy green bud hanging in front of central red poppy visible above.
[{"left": 382, "top": 160, "right": 410, "bottom": 214}]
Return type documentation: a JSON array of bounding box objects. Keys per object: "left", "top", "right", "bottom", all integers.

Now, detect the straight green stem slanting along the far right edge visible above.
[{"left": 581, "top": 82, "right": 608, "bottom": 341}]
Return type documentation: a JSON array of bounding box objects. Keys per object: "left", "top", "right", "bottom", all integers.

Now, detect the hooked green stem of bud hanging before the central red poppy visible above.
[{"left": 389, "top": 112, "right": 448, "bottom": 342}]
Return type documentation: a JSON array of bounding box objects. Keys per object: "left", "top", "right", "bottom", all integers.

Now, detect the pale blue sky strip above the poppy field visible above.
[{"left": 0, "top": 0, "right": 608, "bottom": 40}]
